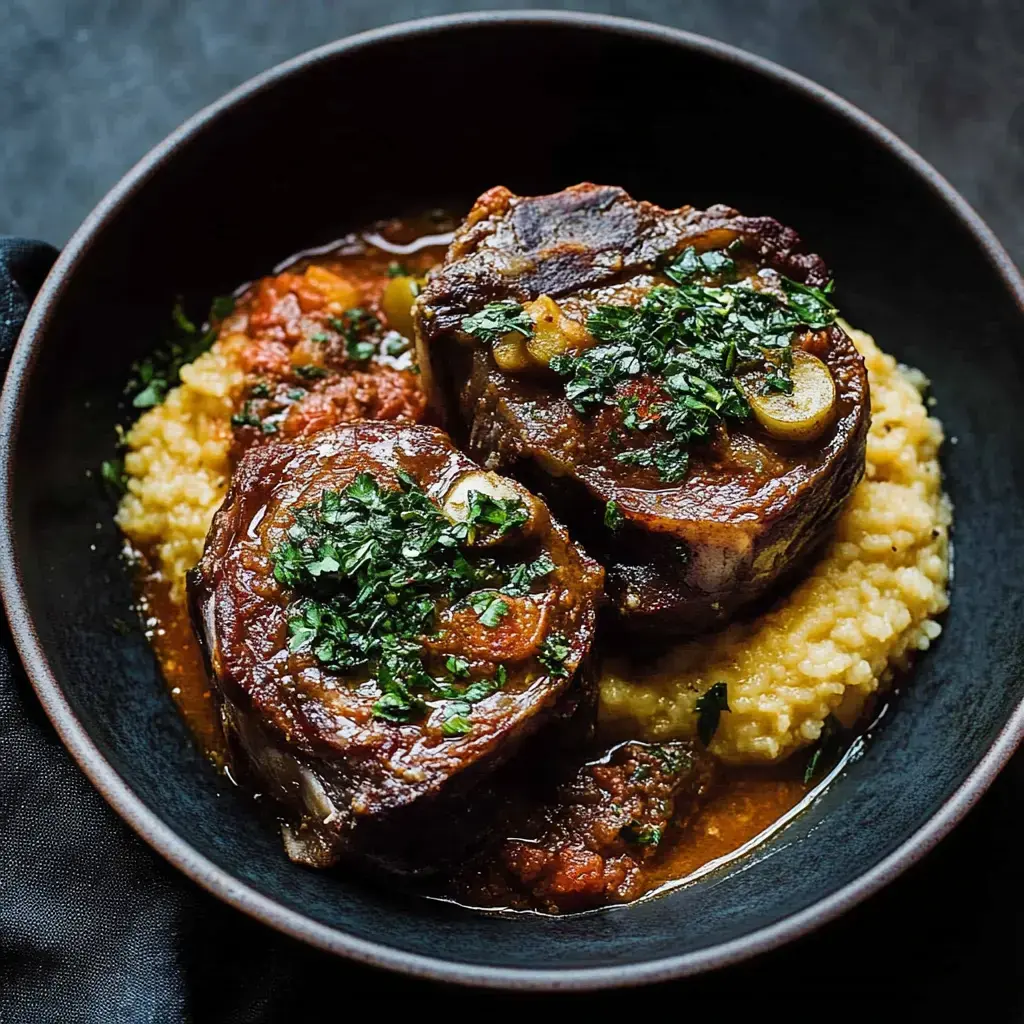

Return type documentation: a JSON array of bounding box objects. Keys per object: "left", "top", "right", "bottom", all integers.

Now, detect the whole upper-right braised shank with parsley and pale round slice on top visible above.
[{"left": 415, "top": 184, "right": 868, "bottom": 633}]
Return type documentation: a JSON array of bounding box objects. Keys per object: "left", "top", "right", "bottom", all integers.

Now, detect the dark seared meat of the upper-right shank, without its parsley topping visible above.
[{"left": 416, "top": 184, "right": 868, "bottom": 633}]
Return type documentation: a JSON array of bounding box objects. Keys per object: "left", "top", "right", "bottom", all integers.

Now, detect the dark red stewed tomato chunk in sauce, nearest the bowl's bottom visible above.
[{"left": 457, "top": 742, "right": 713, "bottom": 911}]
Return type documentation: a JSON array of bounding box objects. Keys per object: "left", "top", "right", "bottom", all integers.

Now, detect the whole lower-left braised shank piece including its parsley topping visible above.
[{"left": 189, "top": 423, "right": 601, "bottom": 871}]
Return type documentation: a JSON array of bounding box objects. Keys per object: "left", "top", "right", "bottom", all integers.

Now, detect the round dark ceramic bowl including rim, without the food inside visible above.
[{"left": 0, "top": 14, "right": 1024, "bottom": 988}]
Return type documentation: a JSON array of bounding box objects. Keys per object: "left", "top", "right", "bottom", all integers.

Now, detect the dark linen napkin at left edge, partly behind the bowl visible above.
[{"left": 0, "top": 237, "right": 196, "bottom": 1024}]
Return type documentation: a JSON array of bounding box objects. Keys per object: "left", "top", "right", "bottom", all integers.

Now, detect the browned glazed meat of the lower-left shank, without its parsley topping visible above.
[{"left": 189, "top": 423, "right": 601, "bottom": 871}]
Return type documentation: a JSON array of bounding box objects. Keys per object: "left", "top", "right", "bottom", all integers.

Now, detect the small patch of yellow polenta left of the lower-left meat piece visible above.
[{"left": 117, "top": 336, "right": 243, "bottom": 601}]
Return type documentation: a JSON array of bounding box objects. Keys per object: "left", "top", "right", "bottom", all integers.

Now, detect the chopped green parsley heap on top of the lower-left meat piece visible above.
[{"left": 272, "top": 473, "right": 548, "bottom": 736}]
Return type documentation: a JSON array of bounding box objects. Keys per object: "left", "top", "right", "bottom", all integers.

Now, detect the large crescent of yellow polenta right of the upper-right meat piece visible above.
[{"left": 600, "top": 325, "right": 950, "bottom": 762}]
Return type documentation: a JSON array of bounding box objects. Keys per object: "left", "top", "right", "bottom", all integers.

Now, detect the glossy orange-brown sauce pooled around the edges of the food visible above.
[{"left": 140, "top": 221, "right": 808, "bottom": 909}]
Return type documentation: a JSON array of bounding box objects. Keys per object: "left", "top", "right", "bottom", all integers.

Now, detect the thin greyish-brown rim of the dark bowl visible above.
[{"left": 0, "top": 10, "right": 1024, "bottom": 991}]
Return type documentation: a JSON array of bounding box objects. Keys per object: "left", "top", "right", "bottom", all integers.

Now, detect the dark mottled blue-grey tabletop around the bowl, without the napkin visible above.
[{"left": 0, "top": 0, "right": 1024, "bottom": 1021}]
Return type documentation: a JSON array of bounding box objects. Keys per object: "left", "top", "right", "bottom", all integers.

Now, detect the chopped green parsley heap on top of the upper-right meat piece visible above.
[{"left": 548, "top": 247, "right": 837, "bottom": 482}]
